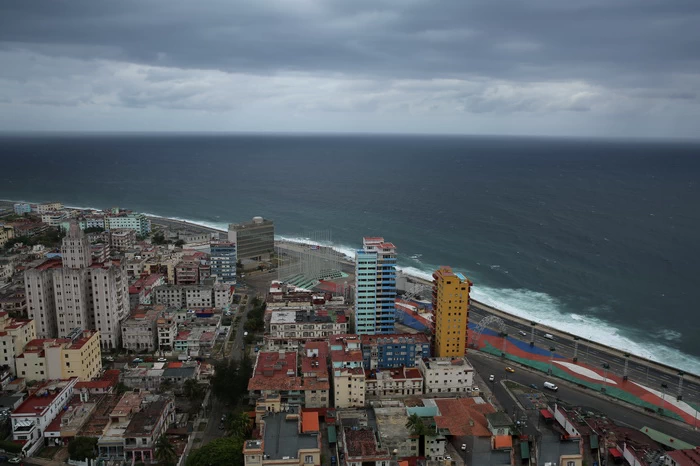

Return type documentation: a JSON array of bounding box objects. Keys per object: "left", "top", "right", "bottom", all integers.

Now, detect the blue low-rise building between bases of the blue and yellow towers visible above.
[{"left": 361, "top": 333, "right": 430, "bottom": 369}]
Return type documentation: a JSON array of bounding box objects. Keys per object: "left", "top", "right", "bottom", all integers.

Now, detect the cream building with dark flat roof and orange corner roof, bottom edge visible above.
[{"left": 243, "top": 408, "right": 321, "bottom": 466}]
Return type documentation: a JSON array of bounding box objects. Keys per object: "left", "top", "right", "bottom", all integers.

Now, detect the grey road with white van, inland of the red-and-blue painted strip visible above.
[{"left": 460, "top": 351, "right": 700, "bottom": 444}]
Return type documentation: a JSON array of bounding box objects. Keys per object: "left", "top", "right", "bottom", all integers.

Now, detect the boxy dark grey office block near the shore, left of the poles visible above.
[{"left": 228, "top": 217, "right": 275, "bottom": 261}]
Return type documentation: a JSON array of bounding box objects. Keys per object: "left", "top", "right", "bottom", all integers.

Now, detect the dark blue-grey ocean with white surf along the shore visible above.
[{"left": 0, "top": 135, "right": 700, "bottom": 373}]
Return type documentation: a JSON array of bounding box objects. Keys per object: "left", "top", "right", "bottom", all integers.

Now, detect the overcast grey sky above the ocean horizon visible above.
[{"left": 0, "top": 0, "right": 700, "bottom": 138}]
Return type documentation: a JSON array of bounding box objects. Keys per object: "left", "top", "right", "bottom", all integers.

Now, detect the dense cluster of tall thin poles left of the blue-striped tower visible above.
[{"left": 275, "top": 230, "right": 348, "bottom": 290}]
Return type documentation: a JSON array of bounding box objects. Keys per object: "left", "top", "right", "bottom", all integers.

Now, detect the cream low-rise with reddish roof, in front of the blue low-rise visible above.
[{"left": 365, "top": 367, "right": 423, "bottom": 399}]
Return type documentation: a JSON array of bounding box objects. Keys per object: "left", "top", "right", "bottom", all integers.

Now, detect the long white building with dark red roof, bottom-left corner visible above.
[{"left": 11, "top": 377, "right": 78, "bottom": 456}]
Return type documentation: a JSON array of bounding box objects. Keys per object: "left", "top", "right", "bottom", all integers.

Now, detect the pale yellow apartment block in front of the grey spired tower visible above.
[{"left": 16, "top": 329, "right": 102, "bottom": 382}]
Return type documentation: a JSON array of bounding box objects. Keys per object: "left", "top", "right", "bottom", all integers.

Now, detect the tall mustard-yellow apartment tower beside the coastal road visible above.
[{"left": 433, "top": 266, "right": 472, "bottom": 358}]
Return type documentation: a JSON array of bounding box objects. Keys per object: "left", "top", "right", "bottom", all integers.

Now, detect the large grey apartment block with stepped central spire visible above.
[{"left": 24, "top": 222, "right": 129, "bottom": 349}]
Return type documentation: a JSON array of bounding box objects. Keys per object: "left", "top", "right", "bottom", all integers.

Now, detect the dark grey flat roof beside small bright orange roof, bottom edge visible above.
[{"left": 263, "top": 413, "right": 319, "bottom": 460}]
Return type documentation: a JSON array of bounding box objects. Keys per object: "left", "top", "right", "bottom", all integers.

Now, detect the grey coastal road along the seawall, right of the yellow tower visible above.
[{"left": 469, "top": 303, "right": 700, "bottom": 403}]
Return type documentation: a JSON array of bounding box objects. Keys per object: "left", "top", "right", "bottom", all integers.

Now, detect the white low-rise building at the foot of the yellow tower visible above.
[{"left": 418, "top": 357, "right": 474, "bottom": 396}]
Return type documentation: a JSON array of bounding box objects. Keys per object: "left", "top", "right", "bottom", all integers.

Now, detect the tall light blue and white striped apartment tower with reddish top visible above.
[{"left": 355, "top": 237, "right": 396, "bottom": 335}]
